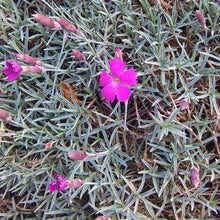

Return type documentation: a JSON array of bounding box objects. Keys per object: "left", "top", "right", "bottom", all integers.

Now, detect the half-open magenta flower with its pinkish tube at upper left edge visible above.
[{"left": 2, "top": 61, "right": 46, "bottom": 81}]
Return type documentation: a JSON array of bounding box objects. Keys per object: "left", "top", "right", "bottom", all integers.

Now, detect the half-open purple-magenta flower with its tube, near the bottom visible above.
[{"left": 49, "top": 174, "right": 84, "bottom": 192}]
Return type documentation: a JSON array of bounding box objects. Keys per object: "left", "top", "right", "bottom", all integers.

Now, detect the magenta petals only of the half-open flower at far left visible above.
[{"left": 2, "top": 61, "right": 22, "bottom": 81}]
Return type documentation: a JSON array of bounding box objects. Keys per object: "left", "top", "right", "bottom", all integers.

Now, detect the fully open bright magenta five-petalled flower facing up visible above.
[{"left": 100, "top": 58, "right": 137, "bottom": 102}]
